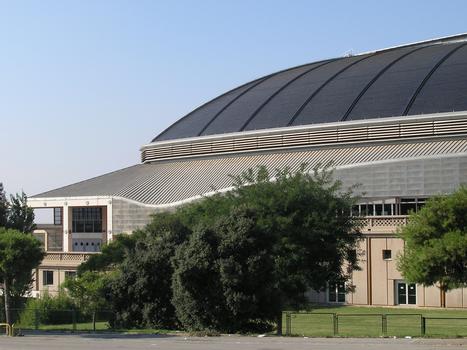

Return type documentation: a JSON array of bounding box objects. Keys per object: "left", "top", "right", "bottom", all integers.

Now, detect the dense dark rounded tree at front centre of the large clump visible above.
[{"left": 173, "top": 208, "right": 281, "bottom": 332}]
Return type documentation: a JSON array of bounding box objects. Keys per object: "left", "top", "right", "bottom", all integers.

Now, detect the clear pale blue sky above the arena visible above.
[{"left": 0, "top": 0, "right": 467, "bottom": 195}]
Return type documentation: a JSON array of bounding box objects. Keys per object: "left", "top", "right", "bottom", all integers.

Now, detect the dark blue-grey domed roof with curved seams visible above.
[{"left": 153, "top": 36, "right": 467, "bottom": 142}]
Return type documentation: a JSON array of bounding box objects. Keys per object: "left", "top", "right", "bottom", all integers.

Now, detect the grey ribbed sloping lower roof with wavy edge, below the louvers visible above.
[{"left": 32, "top": 139, "right": 467, "bottom": 205}]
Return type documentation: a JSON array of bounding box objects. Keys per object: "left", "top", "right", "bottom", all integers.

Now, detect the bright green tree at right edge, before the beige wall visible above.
[{"left": 398, "top": 187, "right": 467, "bottom": 307}]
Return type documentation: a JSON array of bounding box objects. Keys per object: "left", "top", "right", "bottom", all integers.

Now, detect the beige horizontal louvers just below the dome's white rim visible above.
[{"left": 141, "top": 117, "right": 467, "bottom": 163}]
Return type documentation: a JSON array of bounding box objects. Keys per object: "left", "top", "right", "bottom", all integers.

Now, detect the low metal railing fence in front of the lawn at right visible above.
[{"left": 284, "top": 312, "right": 467, "bottom": 337}]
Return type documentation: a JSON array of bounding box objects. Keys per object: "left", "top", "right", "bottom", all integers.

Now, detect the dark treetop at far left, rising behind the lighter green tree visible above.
[{"left": 7, "top": 192, "right": 36, "bottom": 233}]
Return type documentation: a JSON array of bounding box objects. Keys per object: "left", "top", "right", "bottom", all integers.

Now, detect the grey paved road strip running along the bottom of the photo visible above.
[{"left": 0, "top": 334, "right": 467, "bottom": 350}]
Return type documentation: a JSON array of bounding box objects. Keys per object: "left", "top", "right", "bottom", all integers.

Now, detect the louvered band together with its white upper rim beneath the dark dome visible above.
[{"left": 140, "top": 111, "right": 467, "bottom": 163}]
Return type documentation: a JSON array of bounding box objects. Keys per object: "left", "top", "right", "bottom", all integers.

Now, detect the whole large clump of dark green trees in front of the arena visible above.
[{"left": 94, "top": 166, "right": 360, "bottom": 332}]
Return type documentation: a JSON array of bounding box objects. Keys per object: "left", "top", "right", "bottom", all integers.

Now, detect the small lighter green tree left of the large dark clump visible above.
[{"left": 63, "top": 271, "right": 109, "bottom": 331}]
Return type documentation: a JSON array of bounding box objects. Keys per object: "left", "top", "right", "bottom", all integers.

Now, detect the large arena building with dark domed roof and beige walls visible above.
[{"left": 29, "top": 35, "right": 467, "bottom": 307}]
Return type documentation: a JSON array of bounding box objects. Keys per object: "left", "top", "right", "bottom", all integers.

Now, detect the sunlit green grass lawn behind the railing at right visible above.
[{"left": 283, "top": 306, "right": 467, "bottom": 337}]
